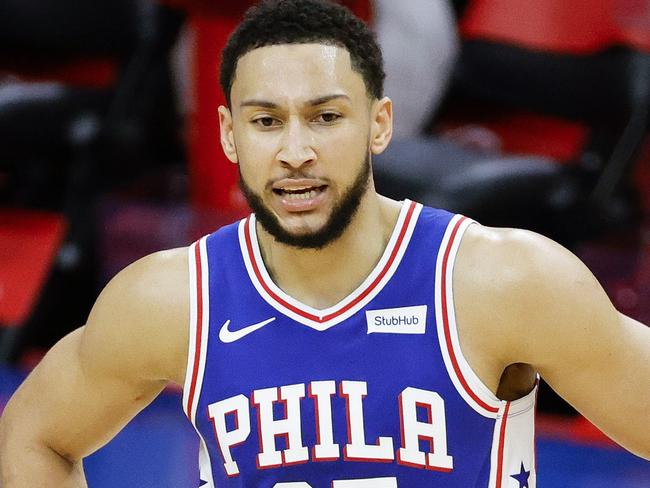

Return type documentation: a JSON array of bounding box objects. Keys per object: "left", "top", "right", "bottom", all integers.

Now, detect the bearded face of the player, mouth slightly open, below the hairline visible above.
[{"left": 220, "top": 44, "right": 384, "bottom": 248}]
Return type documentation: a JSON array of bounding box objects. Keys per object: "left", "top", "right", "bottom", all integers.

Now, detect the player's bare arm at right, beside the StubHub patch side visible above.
[{"left": 454, "top": 225, "right": 650, "bottom": 458}]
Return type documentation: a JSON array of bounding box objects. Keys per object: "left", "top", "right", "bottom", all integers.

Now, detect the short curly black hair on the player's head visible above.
[{"left": 220, "top": 0, "right": 386, "bottom": 106}]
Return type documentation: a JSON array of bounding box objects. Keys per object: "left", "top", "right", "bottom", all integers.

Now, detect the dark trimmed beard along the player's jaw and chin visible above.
[{"left": 238, "top": 154, "right": 371, "bottom": 249}]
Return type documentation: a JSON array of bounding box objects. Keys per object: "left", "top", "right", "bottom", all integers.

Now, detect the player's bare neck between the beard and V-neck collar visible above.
[{"left": 257, "top": 191, "right": 401, "bottom": 309}]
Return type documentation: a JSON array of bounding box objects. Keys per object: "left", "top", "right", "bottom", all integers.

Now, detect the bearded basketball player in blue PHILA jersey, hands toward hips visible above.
[{"left": 0, "top": 0, "right": 650, "bottom": 488}]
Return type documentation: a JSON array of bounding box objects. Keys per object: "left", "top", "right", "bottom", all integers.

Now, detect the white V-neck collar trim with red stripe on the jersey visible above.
[{"left": 238, "top": 200, "right": 422, "bottom": 331}]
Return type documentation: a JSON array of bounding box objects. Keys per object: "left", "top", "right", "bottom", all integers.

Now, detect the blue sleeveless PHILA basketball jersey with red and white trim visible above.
[{"left": 183, "top": 200, "right": 537, "bottom": 488}]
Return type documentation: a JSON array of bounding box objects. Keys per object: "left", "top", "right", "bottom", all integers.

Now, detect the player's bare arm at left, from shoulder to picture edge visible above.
[{"left": 0, "top": 250, "right": 188, "bottom": 488}]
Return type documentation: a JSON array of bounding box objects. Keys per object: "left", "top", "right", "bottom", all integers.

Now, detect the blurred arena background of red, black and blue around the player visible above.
[{"left": 0, "top": 0, "right": 650, "bottom": 488}]
